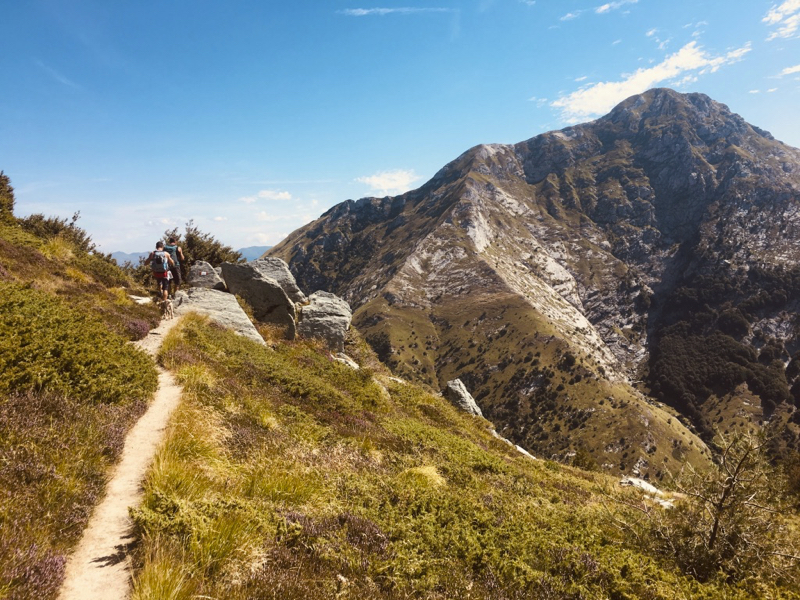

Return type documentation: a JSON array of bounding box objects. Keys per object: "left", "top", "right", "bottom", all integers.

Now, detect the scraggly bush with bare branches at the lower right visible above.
[{"left": 618, "top": 434, "right": 800, "bottom": 583}]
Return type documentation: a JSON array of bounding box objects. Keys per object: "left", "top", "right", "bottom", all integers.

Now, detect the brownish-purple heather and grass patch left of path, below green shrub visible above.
[{"left": 0, "top": 391, "right": 146, "bottom": 599}]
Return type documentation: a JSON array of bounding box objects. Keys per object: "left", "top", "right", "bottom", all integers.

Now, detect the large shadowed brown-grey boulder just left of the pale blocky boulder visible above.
[{"left": 222, "top": 263, "right": 296, "bottom": 340}]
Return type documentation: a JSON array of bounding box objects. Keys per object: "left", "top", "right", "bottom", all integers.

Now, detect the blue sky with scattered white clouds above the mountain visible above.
[{"left": 0, "top": 0, "right": 800, "bottom": 252}]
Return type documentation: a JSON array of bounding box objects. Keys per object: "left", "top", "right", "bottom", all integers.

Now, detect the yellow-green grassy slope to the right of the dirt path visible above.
[{"left": 128, "top": 317, "right": 798, "bottom": 600}]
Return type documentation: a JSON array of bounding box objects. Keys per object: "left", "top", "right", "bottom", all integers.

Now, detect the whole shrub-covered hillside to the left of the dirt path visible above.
[{"left": 0, "top": 215, "right": 158, "bottom": 600}]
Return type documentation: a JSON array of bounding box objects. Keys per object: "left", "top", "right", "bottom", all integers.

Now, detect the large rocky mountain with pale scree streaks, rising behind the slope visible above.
[{"left": 270, "top": 89, "right": 800, "bottom": 477}]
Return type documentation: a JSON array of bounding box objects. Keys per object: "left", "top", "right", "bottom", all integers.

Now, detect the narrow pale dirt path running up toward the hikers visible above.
[{"left": 59, "top": 319, "right": 181, "bottom": 600}]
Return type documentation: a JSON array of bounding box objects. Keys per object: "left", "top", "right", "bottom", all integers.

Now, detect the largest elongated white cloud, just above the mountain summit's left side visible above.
[{"left": 550, "top": 42, "right": 750, "bottom": 123}]
